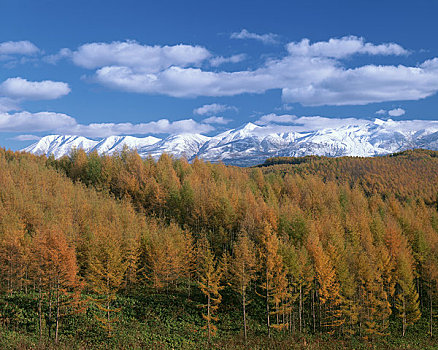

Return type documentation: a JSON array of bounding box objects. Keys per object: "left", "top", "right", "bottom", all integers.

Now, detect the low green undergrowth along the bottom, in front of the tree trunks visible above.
[{"left": 0, "top": 292, "right": 438, "bottom": 350}]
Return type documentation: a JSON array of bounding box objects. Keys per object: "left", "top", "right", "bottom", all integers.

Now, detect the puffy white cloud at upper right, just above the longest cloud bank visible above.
[{"left": 286, "top": 36, "right": 408, "bottom": 58}]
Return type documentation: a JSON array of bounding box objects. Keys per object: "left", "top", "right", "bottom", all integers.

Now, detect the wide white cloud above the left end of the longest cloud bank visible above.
[{"left": 72, "top": 41, "right": 211, "bottom": 73}]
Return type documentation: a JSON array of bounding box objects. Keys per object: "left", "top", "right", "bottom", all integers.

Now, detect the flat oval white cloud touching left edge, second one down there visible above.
[{"left": 0, "top": 77, "right": 70, "bottom": 100}]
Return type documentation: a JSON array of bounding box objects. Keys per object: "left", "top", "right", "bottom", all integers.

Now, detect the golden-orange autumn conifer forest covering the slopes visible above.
[{"left": 0, "top": 150, "right": 438, "bottom": 343}]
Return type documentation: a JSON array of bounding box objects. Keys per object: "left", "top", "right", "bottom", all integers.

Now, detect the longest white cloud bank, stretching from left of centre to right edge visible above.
[{"left": 95, "top": 53, "right": 438, "bottom": 106}]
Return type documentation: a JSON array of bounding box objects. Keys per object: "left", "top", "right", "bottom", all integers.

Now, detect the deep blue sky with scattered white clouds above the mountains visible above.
[{"left": 0, "top": 0, "right": 438, "bottom": 149}]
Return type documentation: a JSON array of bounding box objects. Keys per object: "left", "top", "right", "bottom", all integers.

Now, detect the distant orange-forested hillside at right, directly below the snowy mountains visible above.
[{"left": 258, "top": 149, "right": 438, "bottom": 203}]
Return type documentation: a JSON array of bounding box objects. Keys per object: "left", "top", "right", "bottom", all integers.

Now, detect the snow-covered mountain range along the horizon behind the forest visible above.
[{"left": 23, "top": 119, "right": 438, "bottom": 165}]
